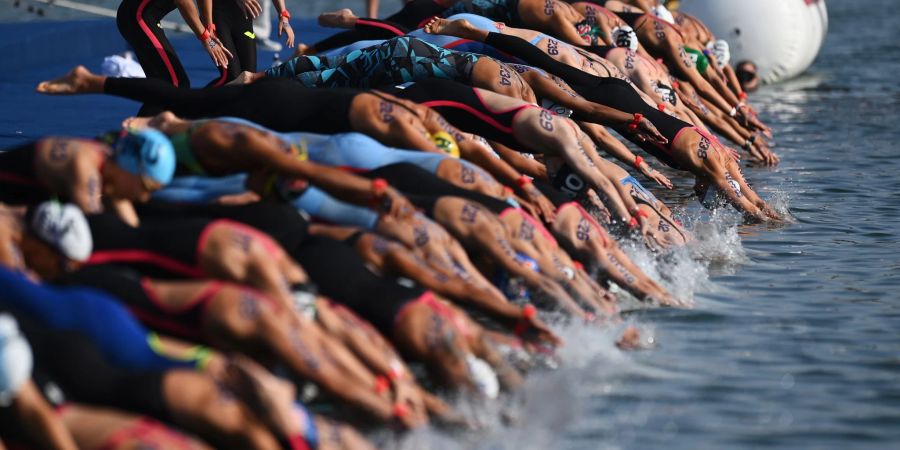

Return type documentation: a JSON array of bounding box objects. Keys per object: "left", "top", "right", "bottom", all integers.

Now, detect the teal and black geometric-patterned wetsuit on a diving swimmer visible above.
[{"left": 266, "top": 36, "right": 479, "bottom": 88}]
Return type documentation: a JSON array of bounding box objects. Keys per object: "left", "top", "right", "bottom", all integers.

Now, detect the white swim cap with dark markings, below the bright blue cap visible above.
[{"left": 30, "top": 200, "right": 94, "bottom": 262}]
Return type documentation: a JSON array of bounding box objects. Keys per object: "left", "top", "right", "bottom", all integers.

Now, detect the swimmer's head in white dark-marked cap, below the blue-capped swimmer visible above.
[{"left": 22, "top": 201, "right": 94, "bottom": 279}]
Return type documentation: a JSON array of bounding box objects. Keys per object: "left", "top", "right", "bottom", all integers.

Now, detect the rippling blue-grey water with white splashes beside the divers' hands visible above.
[{"left": 7, "top": 0, "right": 900, "bottom": 450}]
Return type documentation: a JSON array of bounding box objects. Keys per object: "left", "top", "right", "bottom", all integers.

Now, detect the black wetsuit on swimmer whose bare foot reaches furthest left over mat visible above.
[{"left": 103, "top": 78, "right": 363, "bottom": 134}]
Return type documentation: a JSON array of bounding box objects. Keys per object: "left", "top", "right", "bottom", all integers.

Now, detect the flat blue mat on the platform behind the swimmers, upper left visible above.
[{"left": 0, "top": 19, "right": 335, "bottom": 149}]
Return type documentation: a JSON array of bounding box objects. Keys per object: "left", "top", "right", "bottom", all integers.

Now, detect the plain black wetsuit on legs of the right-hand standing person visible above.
[{"left": 210, "top": 0, "right": 256, "bottom": 86}]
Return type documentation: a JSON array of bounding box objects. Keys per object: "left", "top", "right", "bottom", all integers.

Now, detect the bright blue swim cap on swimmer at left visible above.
[{"left": 113, "top": 128, "right": 176, "bottom": 186}]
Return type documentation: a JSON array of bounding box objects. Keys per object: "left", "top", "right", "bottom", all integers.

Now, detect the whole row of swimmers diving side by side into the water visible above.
[{"left": 0, "top": 0, "right": 782, "bottom": 449}]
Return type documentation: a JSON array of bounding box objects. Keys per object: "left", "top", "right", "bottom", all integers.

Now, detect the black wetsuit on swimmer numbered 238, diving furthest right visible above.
[{"left": 485, "top": 33, "right": 693, "bottom": 169}]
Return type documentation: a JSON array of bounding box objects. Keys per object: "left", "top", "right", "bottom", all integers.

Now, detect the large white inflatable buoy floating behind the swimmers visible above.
[{"left": 678, "top": 0, "right": 828, "bottom": 83}]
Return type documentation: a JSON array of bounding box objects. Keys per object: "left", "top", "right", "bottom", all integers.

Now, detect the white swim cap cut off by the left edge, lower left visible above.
[{"left": 0, "top": 314, "right": 34, "bottom": 407}]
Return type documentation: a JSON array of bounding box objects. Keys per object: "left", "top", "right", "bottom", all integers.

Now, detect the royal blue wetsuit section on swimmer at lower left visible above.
[{"left": 0, "top": 267, "right": 195, "bottom": 370}]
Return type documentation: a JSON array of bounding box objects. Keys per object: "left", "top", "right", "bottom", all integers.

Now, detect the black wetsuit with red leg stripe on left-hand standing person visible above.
[{"left": 116, "top": 0, "right": 191, "bottom": 116}]
